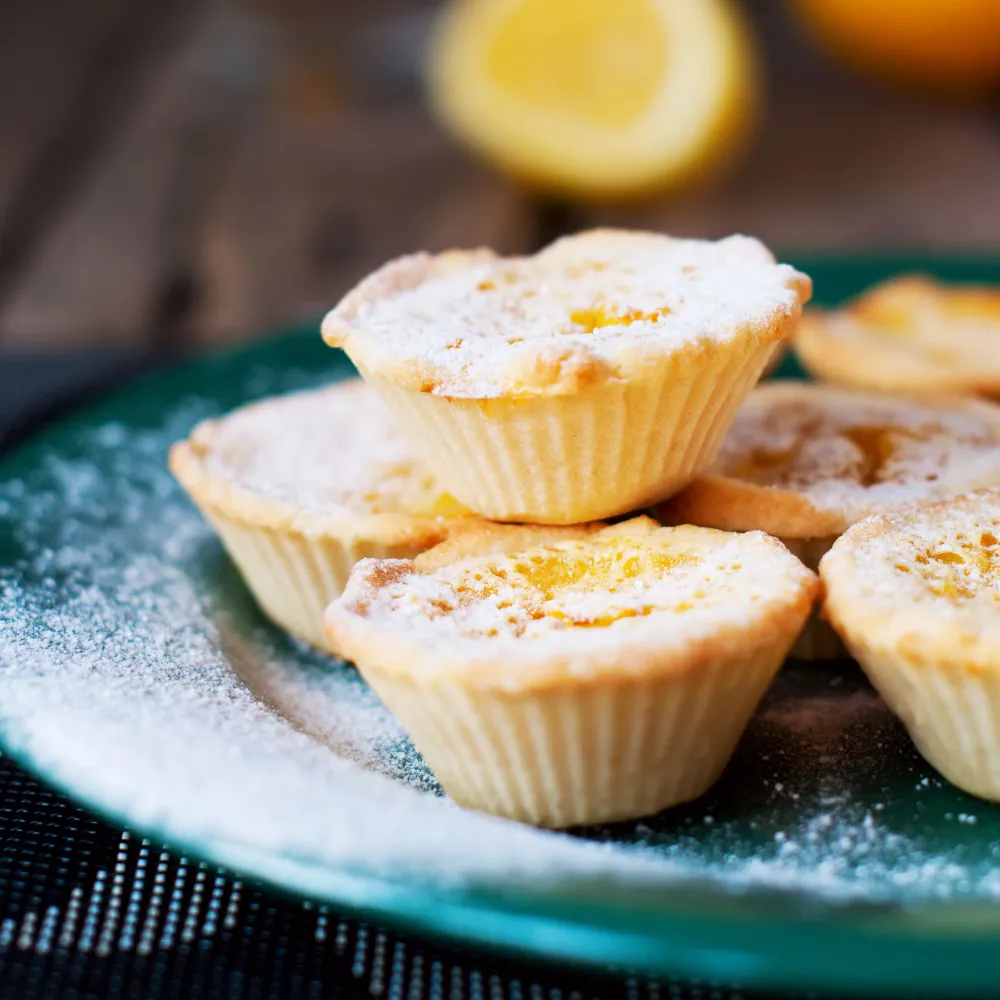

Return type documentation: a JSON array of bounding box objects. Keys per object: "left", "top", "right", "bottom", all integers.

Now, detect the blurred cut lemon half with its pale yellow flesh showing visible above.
[{"left": 428, "top": 0, "right": 758, "bottom": 198}]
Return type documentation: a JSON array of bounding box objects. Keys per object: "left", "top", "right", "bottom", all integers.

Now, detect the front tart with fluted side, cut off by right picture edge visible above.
[{"left": 820, "top": 490, "right": 1000, "bottom": 800}]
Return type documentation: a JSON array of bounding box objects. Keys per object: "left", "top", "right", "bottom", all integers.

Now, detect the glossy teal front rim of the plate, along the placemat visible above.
[{"left": 0, "top": 732, "right": 1000, "bottom": 996}]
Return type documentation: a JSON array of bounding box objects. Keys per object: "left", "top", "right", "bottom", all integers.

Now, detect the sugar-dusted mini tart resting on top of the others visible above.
[{"left": 323, "top": 230, "right": 811, "bottom": 524}]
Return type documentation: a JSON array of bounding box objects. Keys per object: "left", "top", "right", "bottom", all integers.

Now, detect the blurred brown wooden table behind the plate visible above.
[{"left": 0, "top": 0, "right": 1000, "bottom": 364}]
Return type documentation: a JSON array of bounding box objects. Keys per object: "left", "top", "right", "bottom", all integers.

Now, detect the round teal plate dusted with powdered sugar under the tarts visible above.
[{"left": 0, "top": 258, "right": 1000, "bottom": 996}]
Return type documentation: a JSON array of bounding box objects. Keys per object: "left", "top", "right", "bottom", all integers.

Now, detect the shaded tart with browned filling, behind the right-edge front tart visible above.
[{"left": 654, "top": 382, "right": 1000, "bottom": 660}]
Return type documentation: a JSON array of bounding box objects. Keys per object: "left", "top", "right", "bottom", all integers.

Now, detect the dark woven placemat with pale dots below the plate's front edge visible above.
[{"left": 0, "top": 758, "right": 676, "bottom": 1000}]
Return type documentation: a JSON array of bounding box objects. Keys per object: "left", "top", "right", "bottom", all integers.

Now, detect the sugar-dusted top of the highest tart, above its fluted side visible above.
[{"left": 323, "top": 229, "right": 811, "bottom": 398}]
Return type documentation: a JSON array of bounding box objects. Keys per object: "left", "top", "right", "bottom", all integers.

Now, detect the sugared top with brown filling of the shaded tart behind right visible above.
[{"left": 712, "top": 383, "right": 1000, "bottom": 523}]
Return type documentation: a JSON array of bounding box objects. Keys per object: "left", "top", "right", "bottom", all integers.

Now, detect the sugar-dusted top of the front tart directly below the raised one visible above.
[{"left": 341, "top": 518, "right": 812, "bottom": 652}]
